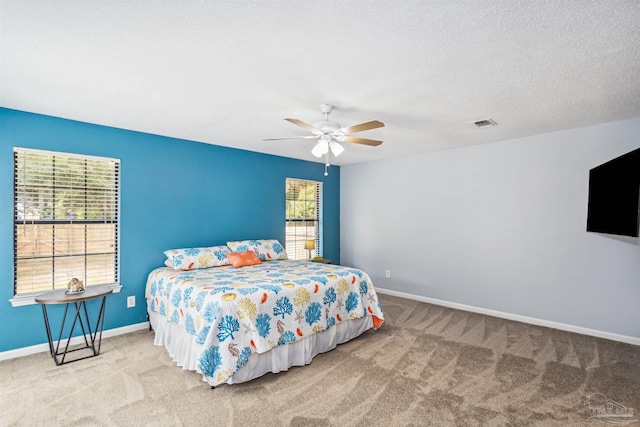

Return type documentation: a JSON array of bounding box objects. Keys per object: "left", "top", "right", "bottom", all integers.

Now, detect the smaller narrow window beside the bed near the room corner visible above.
[{"left": 285, "top": 179, "right": 322, "bottom": 259}]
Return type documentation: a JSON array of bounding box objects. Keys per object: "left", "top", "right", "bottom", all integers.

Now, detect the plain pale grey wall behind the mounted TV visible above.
[{"left": 340, "top": 119, "right": 640, "bottom": 339}]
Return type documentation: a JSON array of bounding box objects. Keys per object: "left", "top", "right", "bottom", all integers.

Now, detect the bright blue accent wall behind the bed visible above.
[{"left": 0, "top": 108, "right": 340, "bottom": 352}]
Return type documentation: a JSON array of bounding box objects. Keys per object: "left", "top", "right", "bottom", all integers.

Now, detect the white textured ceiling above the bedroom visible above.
[{"left": 0, "top": 0, "right": 640, "bottom": 165}]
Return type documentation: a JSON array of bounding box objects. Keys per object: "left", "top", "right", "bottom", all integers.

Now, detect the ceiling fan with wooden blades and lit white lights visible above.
[{"left": 263, "top": 104, "right": 384, "bottom": 176}]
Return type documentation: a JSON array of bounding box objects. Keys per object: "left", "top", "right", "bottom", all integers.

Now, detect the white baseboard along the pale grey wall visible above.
[{"left": 376, "top": 286, "right": 640, "bottom": 346}]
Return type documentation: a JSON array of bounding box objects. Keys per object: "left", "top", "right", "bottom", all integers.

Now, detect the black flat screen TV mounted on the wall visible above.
[{"left": 587, "top": 148, "right": 640, "bottom": 237}]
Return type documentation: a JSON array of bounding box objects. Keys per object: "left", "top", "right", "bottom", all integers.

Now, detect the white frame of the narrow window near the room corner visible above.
[{"left": 284, "top": 178, "right": 323, "bottom": 261}]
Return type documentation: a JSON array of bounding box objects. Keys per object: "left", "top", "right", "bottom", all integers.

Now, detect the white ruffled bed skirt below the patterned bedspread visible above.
[{"left": 149, "top": 311, "right": 373, "bottom": 386}]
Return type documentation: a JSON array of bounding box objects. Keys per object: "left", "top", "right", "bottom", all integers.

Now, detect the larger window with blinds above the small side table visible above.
[{"left": 14, "top": 148, "right": 120, "bottom": 296}]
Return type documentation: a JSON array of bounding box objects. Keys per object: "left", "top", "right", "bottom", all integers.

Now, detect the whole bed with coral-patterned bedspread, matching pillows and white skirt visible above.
[{"left": 146, "top": 240, "right": 384, "bottom": 387}]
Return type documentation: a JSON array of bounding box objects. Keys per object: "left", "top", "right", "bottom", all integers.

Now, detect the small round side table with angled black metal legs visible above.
[{"left": 35, "top": 286, "right": 113, "bottom": 365}]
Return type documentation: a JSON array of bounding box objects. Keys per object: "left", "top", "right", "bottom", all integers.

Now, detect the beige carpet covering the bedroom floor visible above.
[{"left": 0, "top": 295, "right": 640, "bottom": 426}]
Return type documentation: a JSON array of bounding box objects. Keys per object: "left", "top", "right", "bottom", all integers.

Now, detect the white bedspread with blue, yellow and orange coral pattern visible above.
[{"left": 147, "top": 261, "right": 384, "bottom": 384}]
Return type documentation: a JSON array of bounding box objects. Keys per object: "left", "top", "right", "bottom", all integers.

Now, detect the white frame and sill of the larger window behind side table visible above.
[{"left": 10, "top": 147, "right": 122, "bottom": 307}]
